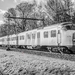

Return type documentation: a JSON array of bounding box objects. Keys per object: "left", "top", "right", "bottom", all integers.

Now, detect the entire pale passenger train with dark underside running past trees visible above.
[{"left": 0, "top": 22, "right": 75, "bottom": 53}]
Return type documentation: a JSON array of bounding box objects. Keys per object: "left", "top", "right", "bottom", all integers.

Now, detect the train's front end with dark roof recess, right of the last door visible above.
[{"left": 63, "top": 23, "right": 75, "bottom": 53}]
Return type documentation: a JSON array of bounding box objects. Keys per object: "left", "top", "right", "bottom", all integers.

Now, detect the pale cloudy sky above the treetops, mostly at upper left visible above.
[{"left": 0, "top": 0, "right": 75, "bottom": 24}]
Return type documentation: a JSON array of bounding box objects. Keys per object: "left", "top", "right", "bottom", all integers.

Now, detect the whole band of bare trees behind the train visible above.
[{"left": 0, "top": 0, "right": 75, "bottom": 36}]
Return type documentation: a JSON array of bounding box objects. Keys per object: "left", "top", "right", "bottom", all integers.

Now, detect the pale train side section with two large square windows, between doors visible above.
[{"left": 41, "top": 28, "right": 58, "bottom": 46}]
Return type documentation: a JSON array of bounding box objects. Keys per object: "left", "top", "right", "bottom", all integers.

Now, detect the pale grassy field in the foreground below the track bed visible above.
[{"left": 0, "top": 49, "right": 75, "bottom": 75}]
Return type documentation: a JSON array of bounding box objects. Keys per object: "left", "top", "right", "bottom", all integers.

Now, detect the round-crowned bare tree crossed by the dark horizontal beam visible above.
[{"left": 16, "top": 2, "right": 34, "bottom": 31}]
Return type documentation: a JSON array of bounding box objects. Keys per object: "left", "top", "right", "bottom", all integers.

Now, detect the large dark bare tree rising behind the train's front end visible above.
[{"left": 47, "top": 0, "right": 72, "bottom": 23}]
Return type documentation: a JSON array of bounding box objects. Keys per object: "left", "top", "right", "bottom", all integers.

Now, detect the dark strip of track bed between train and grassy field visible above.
[{"left": 0, "top": 47, "right": 75, "bottom": 61}]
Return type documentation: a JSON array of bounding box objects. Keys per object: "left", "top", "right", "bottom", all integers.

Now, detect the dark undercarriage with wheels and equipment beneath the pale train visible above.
[{"left": 2, "top": 45, "right": 75, "bottom": 54}]
